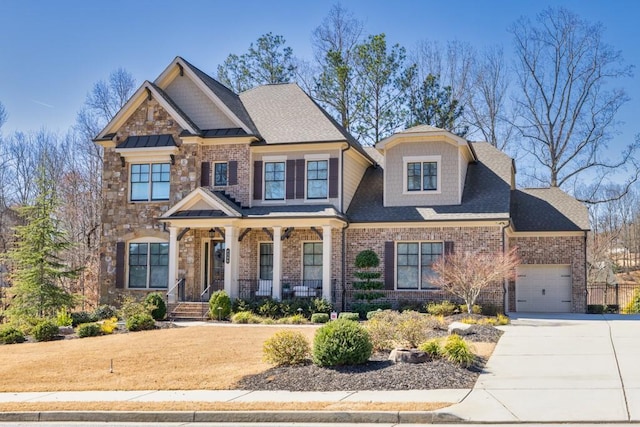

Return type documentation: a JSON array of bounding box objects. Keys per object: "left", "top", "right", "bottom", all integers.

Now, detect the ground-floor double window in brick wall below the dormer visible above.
[{"left": 396, "top": 242, "right": 443, "bottom": 289}]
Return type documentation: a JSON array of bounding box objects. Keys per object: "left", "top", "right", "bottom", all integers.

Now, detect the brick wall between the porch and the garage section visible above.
[{"left": 345, "top": 226, "right": 504, "bottom": 309}]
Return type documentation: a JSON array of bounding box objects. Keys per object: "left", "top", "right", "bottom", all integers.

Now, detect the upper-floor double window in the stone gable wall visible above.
[{"left": 131, "top": 163, "right": 171, "bottom": 202}]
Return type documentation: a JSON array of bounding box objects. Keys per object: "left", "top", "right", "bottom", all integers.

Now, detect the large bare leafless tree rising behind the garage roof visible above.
[{"left": 510, "top": 8, "right": 640, "bottom": 197}]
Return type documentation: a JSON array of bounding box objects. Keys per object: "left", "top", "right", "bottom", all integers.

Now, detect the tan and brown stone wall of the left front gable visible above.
[{"left": 99, "top": 99, "right": 199, "bottom": 304}]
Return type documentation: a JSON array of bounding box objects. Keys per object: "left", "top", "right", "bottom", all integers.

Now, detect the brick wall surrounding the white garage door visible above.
[{"left": 509, "top": 236, "right": 587, "bottom": 313}]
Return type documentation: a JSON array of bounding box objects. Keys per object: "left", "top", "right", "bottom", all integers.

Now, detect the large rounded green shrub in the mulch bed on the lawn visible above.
[{"left": 313, "top": 318, "right": 373, "bottom": 366}]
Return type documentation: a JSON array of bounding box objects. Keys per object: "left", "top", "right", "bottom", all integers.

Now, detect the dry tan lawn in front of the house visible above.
[{"left": 0, "top": 325, "right": 316, "bottom": 392}]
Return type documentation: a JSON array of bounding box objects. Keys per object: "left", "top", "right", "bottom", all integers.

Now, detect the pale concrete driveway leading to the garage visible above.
[{"left": 442, "top": 313, "right": 640, "bottom": 422}]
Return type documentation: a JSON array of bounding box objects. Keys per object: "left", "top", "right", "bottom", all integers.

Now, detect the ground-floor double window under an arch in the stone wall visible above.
[{"left": 129, "top": 243, "right": 169, "bottom": 289}]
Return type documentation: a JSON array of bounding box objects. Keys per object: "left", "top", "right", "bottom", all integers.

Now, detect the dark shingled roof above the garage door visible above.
[{"left": 511, "top": 187, "right": 590, "bottom": 231}]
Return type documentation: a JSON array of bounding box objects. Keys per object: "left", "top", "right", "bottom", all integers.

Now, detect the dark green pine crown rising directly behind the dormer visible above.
[{"left": 407, "top": 74, "right": 469, "bottom": 137}]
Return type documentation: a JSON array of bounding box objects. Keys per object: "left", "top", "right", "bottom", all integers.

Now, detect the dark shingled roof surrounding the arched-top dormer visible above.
[{"left": 347, "top": 142, "right": 512, "bottom": 222}]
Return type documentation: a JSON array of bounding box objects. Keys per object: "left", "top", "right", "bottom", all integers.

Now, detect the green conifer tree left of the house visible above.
[{"left": 7, "top": 167, "right": 77, "bottom": 317}]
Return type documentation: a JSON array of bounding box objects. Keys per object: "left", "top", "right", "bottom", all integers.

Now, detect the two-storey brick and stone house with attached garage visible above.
[{"left": 96, "top": 57, "right": 589, "bottom": 312}]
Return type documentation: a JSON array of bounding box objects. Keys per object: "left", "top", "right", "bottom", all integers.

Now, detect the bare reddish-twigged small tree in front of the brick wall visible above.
[{"left": 431, "top": 248, "right": 520, "bottom": 313}]
